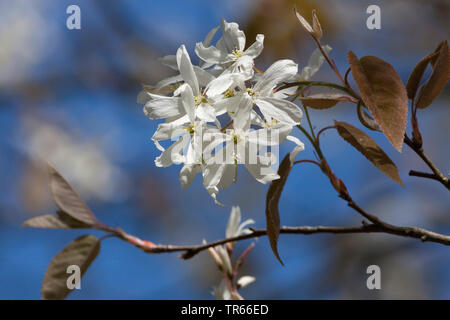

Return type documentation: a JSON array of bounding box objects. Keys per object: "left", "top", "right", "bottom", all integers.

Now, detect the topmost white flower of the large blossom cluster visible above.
[{"left": 195, "top": 19, "right": 264, "bottom": 79}]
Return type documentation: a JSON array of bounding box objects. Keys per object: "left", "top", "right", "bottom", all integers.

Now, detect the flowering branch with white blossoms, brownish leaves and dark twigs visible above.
[{"left": 24, "top": 11, "right": 450, "bottom": 299}]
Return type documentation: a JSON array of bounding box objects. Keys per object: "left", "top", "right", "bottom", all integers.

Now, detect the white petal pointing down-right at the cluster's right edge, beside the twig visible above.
[{"left": 255, "top": 97, "right": 303, "bottom": 125}]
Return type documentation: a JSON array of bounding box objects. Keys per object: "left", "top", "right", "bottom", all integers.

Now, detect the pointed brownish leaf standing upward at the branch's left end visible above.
[{"left": 48, "top": 165, "right": 98, "bottom": 225}]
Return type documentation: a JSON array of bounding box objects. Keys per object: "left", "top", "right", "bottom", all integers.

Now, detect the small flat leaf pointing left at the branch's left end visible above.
[{"left": 22, "top": 210, "right": 92, "bottom": 229}]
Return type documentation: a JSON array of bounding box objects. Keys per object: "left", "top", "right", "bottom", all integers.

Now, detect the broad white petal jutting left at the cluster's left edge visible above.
[{"left": 144, "top": 97, "right": 186, "bottom": 119}]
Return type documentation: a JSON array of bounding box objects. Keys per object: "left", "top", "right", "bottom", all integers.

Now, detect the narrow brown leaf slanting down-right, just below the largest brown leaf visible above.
[{"left": 334, "top": 121, "right": 403, "bottom": 186}]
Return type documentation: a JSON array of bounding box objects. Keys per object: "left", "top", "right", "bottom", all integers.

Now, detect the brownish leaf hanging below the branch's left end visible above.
[{"left": 42, "top": 235, "right": 100, "bottom": 300}]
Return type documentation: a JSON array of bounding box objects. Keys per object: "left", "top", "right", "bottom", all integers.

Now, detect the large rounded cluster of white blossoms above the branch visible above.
[{"left": 138, "top": 20, "right": 329, "bottom": 203}]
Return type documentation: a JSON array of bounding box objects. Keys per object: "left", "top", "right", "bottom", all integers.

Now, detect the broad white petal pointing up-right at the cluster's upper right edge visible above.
[{"left": 254, "top": 59, "right": 298, "bottom": 95}]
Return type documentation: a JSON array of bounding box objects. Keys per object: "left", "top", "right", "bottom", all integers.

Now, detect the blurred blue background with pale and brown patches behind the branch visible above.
[{"left": 0, "top": 0, "right": 450, "bottom": 299}]
